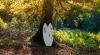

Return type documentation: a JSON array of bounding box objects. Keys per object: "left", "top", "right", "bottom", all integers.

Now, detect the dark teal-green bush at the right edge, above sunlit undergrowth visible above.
[{"left": 80, "top": 11, "right": 100, "bottom": 32}]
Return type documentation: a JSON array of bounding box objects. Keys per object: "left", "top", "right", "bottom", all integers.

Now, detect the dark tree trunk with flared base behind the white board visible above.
[{"left": 31, "top": 0, "right": 53, "bottom": 45}]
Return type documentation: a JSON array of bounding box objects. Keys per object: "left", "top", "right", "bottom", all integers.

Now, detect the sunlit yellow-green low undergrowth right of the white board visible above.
[{"left": 54, "top": 29, "right": 99, "bottom": 48}]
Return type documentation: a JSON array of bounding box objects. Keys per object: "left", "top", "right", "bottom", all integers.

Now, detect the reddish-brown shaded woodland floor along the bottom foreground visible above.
[{"left": 0, "top": 44, "right": 100, "bottom": 55}]
